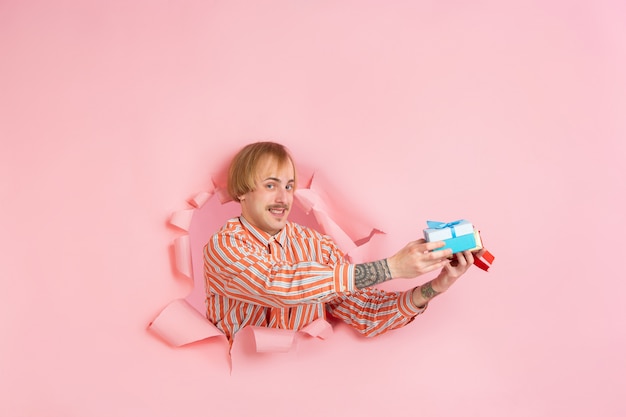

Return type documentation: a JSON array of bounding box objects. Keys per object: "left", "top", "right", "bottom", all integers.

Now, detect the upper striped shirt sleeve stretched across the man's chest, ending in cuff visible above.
[{"left": 204, "top": 232, "right": 354, "bottom": 308}]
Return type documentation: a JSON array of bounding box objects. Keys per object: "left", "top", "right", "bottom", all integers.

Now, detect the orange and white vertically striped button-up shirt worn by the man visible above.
[{"left": 204, "top": 217, "right": 425, "bottom": 342}]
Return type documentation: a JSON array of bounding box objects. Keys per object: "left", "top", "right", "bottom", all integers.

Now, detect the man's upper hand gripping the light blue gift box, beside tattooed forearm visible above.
[{"left": 387, "top": 239, "right": 456, "bottom": 278}]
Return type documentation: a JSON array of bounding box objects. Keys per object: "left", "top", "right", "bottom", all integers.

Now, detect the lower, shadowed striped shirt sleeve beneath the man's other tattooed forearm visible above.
[{"left": 327, "top": 288, "right": 427, "bottom": 337}]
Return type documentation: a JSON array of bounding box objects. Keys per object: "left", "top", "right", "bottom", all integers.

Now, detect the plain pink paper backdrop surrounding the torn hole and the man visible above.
[{"left": 0, "top": 0, "right": 626, "bottom": 417}]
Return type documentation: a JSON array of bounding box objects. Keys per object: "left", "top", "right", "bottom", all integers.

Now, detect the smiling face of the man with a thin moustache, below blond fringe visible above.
[{"left": 239, "top": 156, "right": 295, "bottom": 235}]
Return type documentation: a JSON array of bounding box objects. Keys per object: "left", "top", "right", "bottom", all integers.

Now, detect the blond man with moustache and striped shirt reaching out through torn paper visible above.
[{"left": 204, "top": 142, "right": 474, "bottom": 342}]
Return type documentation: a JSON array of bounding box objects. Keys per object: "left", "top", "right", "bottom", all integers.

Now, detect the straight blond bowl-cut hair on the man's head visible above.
[{"left": 228, "top": 142, "right": 295, "bottom": 201}]
